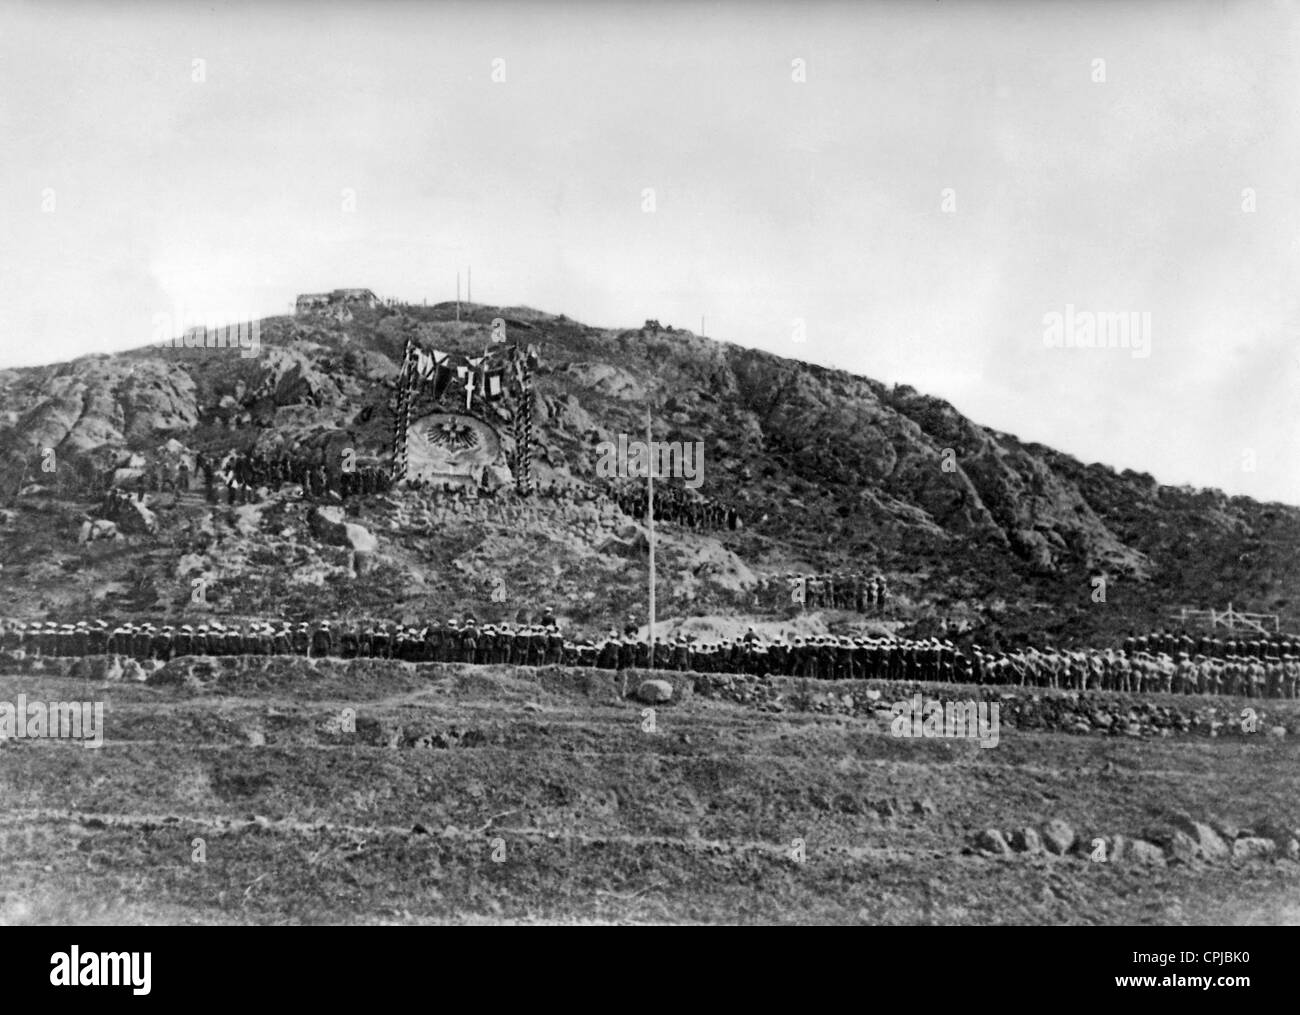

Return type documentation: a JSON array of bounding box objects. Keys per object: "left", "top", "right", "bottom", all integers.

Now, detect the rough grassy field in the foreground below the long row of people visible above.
[{"left": 0, "top": 660, "right": 1300, "bottom": 924}]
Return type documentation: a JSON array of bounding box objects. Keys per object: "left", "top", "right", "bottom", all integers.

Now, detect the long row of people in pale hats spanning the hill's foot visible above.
[{"left": 0, "top": 612, "right": 1300, "bottom": 698}]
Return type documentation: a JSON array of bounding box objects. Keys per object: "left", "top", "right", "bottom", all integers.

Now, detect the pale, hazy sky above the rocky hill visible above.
[{"left": 0, "top": 0, "right": 1300, "bottom": 504}]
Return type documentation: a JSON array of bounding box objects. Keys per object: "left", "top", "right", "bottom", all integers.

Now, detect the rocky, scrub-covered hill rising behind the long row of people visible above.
[{"left": 0, "top": 304, "right": 1300, "bottom": 642}]
